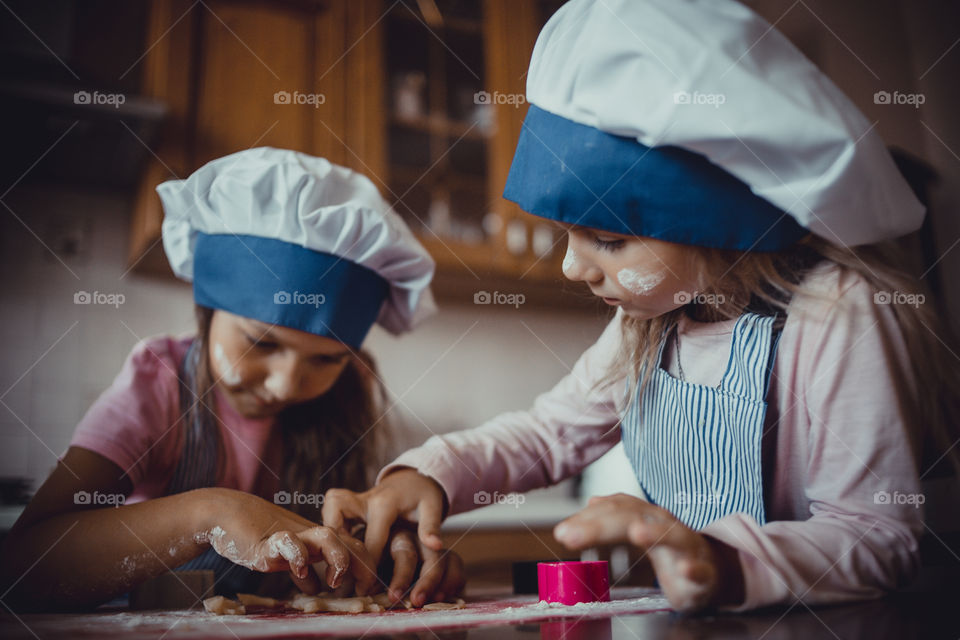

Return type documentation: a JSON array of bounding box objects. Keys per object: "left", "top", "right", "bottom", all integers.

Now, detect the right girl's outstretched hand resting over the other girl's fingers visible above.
[{"left": 323, "top": 469, "right": 446, "bottom": 565}]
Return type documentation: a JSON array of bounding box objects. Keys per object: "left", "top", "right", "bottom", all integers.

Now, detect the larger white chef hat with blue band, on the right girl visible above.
[{"left": 504, "top": 0, "right": 924, "bottom": 251}]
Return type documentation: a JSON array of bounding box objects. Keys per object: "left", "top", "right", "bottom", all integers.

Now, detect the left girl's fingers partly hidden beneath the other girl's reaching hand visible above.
[{"left": 387, "top": 528, "right": 466, "bottom": 607}]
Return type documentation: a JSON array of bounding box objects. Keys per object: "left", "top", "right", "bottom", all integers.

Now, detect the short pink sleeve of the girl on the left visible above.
[{"left": 70, "top": 338, "right": 179, "bottom": 488}]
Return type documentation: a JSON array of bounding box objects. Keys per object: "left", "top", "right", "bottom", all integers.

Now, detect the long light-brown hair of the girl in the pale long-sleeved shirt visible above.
[{"left": 600, "top": 235, "right": 960, "bottom": 476}]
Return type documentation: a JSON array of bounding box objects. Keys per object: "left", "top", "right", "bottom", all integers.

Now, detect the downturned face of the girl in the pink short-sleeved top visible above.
[{"left": 208, "top": 309, "right": 351, "bottom": 418}]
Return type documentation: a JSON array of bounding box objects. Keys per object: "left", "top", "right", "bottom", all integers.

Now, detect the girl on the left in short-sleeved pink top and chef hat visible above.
[{"left": 2, "top": 148, "right": 463, "bottom": 609}]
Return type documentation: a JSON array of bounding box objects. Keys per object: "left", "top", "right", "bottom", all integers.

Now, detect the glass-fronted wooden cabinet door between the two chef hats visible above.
[{"left": 381, "top": 0, "right": 563, "bottom": 289}]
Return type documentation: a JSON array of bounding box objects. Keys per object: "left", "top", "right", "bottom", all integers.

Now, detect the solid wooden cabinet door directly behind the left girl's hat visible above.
[{"left": 129, "top": 0, "right": 386, "bottom": 273}]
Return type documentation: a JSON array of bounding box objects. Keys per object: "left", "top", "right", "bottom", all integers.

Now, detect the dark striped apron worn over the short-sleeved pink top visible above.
[{"left": 166, "top": 341, "right": 264, "bottom": 597}]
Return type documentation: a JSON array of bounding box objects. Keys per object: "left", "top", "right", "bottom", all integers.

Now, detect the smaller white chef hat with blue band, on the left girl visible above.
[{"left": 157, "top": 147, "right": 436, "bottom": 346}]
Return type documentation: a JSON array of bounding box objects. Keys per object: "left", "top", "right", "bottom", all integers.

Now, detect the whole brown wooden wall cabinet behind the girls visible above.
[{"left": 130, "top": 0, "right": 579, "bottom": 305}]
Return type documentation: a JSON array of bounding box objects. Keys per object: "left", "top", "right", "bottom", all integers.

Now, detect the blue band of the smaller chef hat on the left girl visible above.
[{"left": 193, "top": 233, "right": 390, "bottom": 347}]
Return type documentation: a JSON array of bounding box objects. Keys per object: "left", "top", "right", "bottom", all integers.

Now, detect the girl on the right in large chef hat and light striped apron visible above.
[{"left": 324, "top": 0, "right": 958, "bottom": 611}]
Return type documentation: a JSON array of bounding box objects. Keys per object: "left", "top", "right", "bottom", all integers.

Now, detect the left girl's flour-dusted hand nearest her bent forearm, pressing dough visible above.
[{"left": 197, "top": 489, "right": 377, "bottom": 595}]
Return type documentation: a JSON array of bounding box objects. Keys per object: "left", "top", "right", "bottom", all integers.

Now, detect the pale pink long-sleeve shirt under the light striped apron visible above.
[{"left": 379, "top": 267, "right": 923, "bottom": 610}]
